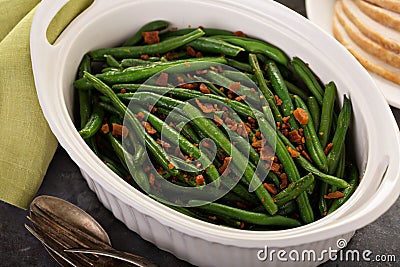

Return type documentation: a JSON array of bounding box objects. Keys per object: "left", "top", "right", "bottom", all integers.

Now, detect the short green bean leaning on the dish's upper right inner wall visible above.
[{"left": 291, "top": 57, "right": 324, "bottom": 106}]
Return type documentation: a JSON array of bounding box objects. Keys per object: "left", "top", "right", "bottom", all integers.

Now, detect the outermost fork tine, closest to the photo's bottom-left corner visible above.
[{"left": 25, "top": 224, "right": 94, "bottom": 267}]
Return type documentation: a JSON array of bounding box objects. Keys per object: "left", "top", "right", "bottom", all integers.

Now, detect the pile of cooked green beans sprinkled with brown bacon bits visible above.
[{"left": 74, "top": 20, "right": 360, "bottom": 230}]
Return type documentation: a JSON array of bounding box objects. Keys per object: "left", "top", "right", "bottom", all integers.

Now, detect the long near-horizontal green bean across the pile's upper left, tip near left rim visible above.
[{"left": 74, "top": 57, "right": 226, "bottom": 89}]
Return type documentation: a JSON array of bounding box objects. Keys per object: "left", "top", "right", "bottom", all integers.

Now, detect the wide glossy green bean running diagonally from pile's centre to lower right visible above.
[{"left": 182, "top": 103, "right": 278, "bottom": 215}]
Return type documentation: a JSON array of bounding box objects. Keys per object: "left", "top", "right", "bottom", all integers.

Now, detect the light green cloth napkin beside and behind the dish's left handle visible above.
[{"left": 0, "top": 0, "right": 92, "bottom": 209}]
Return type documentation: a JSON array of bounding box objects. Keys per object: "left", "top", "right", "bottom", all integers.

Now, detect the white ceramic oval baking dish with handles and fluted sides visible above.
[{"left": 31, "top": 0, "right": 400, "bottom": 266}]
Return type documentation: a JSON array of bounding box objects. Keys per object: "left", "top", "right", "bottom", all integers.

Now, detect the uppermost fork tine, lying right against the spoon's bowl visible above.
[{"left": 31, "top": 203, "right": 111, "bottom": 249}]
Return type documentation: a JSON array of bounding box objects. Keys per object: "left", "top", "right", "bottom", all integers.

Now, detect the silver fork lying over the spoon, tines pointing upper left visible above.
[{"left": 25, "top": 203, "right": 156, "bottom": 267}]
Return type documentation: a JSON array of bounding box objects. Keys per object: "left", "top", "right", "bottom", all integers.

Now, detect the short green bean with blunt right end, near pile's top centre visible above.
[{"left": 187, "top": 37, "right": 244, "bottom": 57}]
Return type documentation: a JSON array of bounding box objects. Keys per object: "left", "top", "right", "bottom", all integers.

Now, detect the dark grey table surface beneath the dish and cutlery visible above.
[{"left": 0, "top": 0, "right": 400, "bottom": 267}]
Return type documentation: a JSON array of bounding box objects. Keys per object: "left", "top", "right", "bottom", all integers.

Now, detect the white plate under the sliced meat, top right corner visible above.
[{"left": 306, "top": 0, "right": 400, "bottom": 108}]
